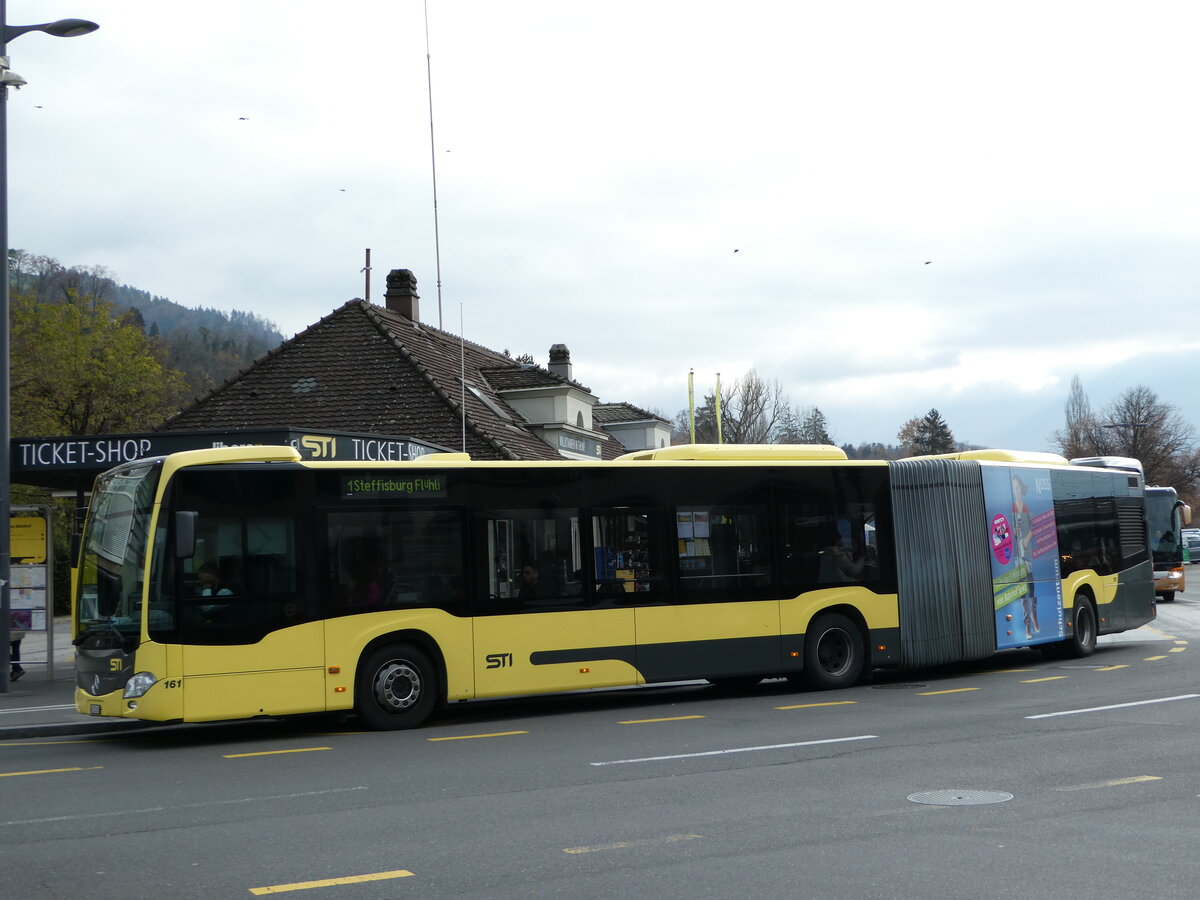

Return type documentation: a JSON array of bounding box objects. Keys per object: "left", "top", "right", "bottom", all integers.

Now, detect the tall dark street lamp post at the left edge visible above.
[{"left": 0, "top": 0, "right": 100, "bottom": 694}]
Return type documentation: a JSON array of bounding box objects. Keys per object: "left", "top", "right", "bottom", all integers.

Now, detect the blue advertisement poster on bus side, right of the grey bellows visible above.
[{"left": 983, "top": 466, "right": 1064, "bottom": 649}]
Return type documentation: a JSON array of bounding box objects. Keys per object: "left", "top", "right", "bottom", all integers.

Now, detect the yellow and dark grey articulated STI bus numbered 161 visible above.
[{"left": 74, "top": 445, "right": 1154, "bottom": 728}]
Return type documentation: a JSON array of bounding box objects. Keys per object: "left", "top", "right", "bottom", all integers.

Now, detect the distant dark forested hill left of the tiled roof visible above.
[{"left": 8, "top": 250, "right": 283, "bottom": 395}]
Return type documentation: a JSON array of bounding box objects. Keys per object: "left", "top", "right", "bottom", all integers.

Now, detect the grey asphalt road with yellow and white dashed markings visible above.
[{"left": 0, "top": 592, "right": 1200, "bottom": 900}]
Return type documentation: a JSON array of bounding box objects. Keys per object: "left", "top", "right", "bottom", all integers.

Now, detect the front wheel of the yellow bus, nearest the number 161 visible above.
[{"left": 354, "top": 643, "right": 438, "bottom": 731}]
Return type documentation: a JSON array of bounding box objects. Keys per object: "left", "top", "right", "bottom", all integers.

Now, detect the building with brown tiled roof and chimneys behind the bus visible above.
[{"left": 162, "top": 269, "right": 671, "bottom": 460}]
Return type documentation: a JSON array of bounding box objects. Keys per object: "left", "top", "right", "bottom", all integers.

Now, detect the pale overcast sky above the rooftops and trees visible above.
[{"left": 8, "top": 0, "right": 1200, "bottom": 450}]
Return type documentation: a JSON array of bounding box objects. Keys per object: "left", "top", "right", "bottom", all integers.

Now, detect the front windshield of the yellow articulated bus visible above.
[{"left": 76, "top": 462, "right": 160, "bottom": 637}]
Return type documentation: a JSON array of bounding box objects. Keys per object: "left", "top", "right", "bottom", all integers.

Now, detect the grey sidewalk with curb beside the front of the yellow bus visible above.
[{"left": 0, "top": 617, "right": 153, "bottom": 740}]
